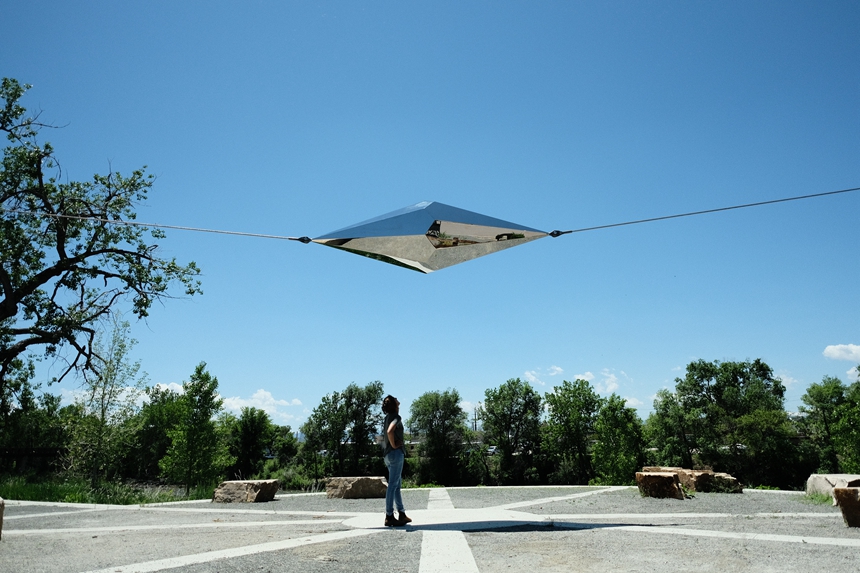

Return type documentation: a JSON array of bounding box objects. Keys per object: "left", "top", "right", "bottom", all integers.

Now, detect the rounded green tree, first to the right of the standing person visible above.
[{"left": 406, "top": 390, "right": 468, "bottom": 485}]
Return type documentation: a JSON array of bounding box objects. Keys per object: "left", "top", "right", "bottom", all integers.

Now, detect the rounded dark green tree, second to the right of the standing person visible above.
[{"left": 480, "top": 378, "right": 541, "bottom": 484}]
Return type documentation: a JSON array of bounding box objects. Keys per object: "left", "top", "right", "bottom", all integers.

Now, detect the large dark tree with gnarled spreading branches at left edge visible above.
[{"left": 0, "top": 78, "right": 201, "bottom": 396}]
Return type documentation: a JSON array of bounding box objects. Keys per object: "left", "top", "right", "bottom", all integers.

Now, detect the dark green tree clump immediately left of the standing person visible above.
[{"left": 301, "top": 381, "right": 382, "bottom": 479}]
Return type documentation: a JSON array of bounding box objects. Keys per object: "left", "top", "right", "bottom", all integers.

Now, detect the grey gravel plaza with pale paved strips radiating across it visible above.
[{"left": 0, "top": 486, "right": 860, "bottom": 573}]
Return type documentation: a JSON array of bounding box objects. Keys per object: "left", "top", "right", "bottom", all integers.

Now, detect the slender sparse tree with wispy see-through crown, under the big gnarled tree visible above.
[{"left": 67, "top": 317, "right": 145, "bottom": 488}]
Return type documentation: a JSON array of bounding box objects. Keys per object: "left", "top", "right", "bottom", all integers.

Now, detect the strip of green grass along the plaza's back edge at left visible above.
[{"left": 0, "top": 477, "right": 214, "bottom": 505}]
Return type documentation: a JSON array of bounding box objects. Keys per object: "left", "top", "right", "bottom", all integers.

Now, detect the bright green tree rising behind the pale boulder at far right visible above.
[{"left": 800, "top": 376, "right": 846, "bottom": 473}]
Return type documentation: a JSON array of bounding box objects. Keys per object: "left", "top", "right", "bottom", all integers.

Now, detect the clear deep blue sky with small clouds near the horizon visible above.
[{"left": 0, "top": 0, "right": 860, "bottom": 428}]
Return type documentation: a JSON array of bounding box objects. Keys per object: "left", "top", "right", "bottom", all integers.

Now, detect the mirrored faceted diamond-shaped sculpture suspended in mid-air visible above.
[{"left": 313, "top": 202, "right": 547, "bottom": 273}]
